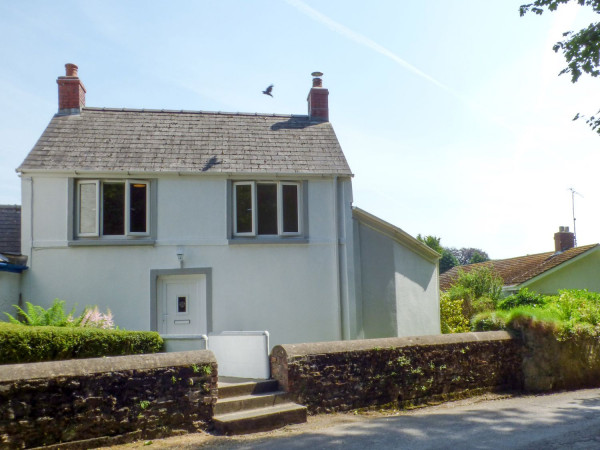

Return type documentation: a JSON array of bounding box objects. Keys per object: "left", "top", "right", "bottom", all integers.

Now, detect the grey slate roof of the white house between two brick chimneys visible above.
[{"left": 17, "top": 107, "right": 352, "bottom": 176}]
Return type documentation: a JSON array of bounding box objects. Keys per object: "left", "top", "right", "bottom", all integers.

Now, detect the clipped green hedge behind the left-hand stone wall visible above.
[{"left": 0, "top": 322, "right": 163, "bottom": 364}]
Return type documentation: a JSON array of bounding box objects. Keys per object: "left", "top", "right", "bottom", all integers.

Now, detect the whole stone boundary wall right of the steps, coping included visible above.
[{"left": 271, "top": 331, "right": 523, "bottom": 413}]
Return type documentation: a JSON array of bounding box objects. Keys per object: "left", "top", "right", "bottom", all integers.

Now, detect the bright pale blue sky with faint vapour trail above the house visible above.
[{"left": 0, "top": 0, "right": 600, "bottom": 258}]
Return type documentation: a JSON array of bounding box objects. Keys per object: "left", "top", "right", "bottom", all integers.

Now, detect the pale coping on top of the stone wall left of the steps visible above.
[{"left": 0, "top": 350, "right": 217, "bottom": 382}]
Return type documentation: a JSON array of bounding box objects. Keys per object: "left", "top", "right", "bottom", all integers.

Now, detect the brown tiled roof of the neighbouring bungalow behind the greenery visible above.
[{"left": 440, "top": 244, "right": 599, "bottom": 291}]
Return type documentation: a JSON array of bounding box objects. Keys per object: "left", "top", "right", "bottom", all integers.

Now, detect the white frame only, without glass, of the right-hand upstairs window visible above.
[{"left": 232, "top": 180, "right": 303, "bottom": 238}]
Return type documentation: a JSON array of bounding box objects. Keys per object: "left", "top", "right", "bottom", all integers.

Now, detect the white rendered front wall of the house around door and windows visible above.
[{"left": 23, "top": 176, "right": 341, "bottom": 345}]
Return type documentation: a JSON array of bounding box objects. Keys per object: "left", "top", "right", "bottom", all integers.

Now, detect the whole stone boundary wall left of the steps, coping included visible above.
[{"left": 0, "top": 350, "right": 218, "bottom": 448}]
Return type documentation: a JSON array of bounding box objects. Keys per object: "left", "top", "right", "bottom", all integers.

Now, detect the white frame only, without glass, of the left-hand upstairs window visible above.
[{"left": 75, "top": 179, "right": 151, "bottom": 239}]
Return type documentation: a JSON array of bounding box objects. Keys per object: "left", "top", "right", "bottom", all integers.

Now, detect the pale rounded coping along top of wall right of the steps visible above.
[{"left": 272, "top": 331, "right": 514, "bottom": 358}]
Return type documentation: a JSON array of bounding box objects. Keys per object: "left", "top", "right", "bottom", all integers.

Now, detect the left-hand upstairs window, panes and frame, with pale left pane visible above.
[{"left": 75, "top": 180, "right": 150, "bottom": 237}]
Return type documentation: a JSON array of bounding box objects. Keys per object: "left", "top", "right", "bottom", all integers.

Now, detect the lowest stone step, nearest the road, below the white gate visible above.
[{"left": 213, "top": 403, "right": 306, "bottom": 435}]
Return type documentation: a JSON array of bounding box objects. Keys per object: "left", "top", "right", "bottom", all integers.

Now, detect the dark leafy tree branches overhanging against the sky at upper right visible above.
[{"left": 519, "top": 0, "right": 600, "bottom": 134}]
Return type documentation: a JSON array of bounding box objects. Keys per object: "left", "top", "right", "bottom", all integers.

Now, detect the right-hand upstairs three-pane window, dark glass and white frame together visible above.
[{"left": 233, "top": 181, "right": 302, "bottom": 236}]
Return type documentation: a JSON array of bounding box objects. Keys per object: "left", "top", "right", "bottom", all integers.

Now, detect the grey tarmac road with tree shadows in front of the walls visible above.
[{"left": 115, "top": 389, "right": 600, "bottom": 450}]
